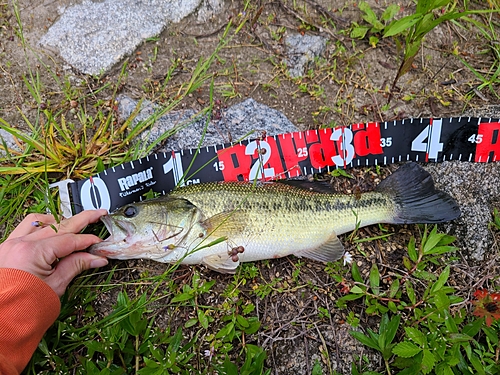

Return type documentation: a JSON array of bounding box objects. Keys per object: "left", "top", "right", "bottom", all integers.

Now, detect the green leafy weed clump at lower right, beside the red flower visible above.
[{"left": 346, "top": 227, "right": 500, "bottom": 374}]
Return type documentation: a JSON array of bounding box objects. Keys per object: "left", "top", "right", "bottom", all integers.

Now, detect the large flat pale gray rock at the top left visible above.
[{"left": 39, "top": 0, "right": 223, "bottom": 75}]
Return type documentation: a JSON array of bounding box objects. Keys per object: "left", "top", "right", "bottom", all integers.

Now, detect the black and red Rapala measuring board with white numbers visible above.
[{"left": 54, "top": 117, "right": 500, "bottom": 216}]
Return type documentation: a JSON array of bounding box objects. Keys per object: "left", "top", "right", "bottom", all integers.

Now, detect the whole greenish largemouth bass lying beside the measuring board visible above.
[{"left": 90, "top": 163, "right": 460, "bottom": 273}]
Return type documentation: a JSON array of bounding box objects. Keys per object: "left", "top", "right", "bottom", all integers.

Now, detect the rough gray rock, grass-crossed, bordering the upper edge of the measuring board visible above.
[{"left": 117, "top": 96, "right": 298, "bottom": 151}]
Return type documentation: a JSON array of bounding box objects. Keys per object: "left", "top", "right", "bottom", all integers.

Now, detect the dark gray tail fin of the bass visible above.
[{"left": 376, "top": 163, "right": 460, "bottom": 224}]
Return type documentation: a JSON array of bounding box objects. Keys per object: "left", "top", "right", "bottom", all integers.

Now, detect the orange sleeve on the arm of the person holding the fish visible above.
[{"left": 0, "top": 268, "right": 61, "bottom": 375}]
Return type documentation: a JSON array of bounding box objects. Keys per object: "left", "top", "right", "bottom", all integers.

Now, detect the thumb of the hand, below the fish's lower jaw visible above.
[{"left": 44, "top": 252, "right": 108, "bottom": 297}]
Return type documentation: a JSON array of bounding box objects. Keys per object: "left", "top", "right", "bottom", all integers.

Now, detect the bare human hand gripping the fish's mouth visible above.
[{"left": 0, "top": 210, "right": 108, "bottom": 297}]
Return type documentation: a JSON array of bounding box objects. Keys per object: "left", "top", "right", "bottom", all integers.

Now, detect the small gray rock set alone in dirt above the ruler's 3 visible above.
[{"left": 285, "top": 34, "right": 327, "bottom": 78}]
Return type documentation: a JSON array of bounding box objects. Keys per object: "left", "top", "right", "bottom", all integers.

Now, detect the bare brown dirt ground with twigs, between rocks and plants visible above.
[{"left": 0, "top": 0, "right": 500, "bottom": 375}]
